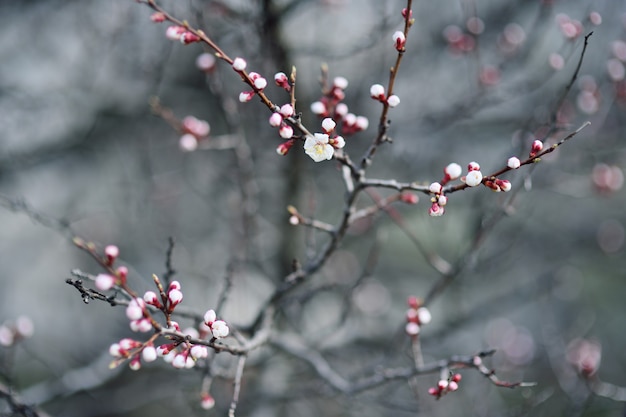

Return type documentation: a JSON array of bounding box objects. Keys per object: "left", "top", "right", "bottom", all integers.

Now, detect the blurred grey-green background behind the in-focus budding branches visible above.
[{"left": 0, "top": 0, "right": 626, "bottom": 417}]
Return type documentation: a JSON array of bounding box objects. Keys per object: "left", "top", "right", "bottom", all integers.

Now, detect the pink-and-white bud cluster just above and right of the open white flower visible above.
[{"left": 311, "top": 77, "right": 369, "bottom": 136}]
